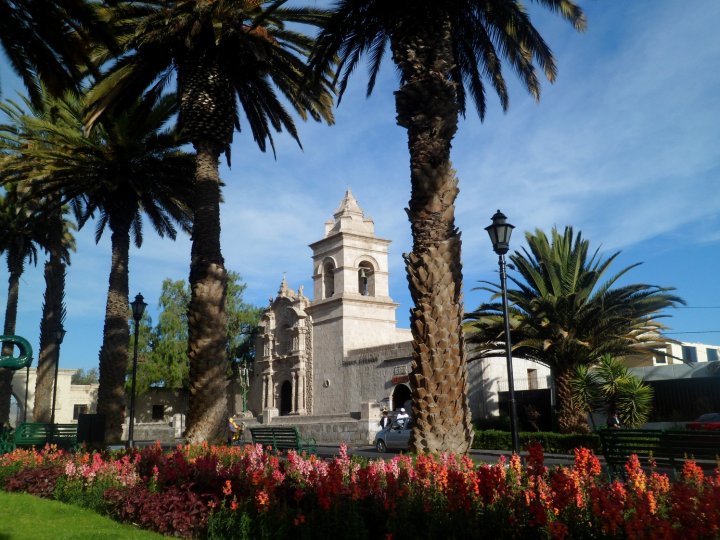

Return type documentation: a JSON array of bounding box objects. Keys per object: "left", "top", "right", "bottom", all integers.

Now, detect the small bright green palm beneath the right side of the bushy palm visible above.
[{"left": 570, "top": 354, "right": 653, "bottom": 428}]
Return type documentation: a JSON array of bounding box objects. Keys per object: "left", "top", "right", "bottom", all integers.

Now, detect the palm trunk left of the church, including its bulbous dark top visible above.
[{"left": 178, "top": 58, "right": 235, "bottom": 443}]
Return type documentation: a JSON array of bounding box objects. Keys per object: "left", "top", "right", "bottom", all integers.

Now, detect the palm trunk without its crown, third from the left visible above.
[{"left": 97, "top": 216, "right": 130, "bottom": 444}]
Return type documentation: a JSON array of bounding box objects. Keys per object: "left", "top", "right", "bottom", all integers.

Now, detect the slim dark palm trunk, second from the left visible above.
[{"left": 33, "top": 214, "right": 65, "bottom": 422}]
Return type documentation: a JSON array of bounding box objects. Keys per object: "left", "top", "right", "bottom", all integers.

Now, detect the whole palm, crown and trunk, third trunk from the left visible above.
[{"left": 2, "top": 89, "right": 193, "bottom": 442}]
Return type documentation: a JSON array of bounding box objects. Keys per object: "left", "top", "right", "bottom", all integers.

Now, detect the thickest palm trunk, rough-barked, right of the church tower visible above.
[{"left": 391, "top": 14, "right": 473, "bottom": 453}]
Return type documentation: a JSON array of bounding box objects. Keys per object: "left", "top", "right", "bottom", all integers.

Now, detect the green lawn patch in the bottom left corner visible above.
[{"left": 0, "top": 491, "right": 164, "bottom": 540}]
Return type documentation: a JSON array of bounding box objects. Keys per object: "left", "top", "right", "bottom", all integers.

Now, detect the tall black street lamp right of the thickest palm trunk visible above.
[{"left": 485, "top": 210, "right": 520, "bottom": 454}]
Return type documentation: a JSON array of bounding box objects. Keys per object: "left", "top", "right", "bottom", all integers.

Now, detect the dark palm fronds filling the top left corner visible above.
[{"left": 0, "top": 0, "right": 115, "bottom": 105}]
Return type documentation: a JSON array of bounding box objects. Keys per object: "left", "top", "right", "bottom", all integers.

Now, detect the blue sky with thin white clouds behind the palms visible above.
[{"left": 0, "top": 0, "right": 720, "bottom": 369}]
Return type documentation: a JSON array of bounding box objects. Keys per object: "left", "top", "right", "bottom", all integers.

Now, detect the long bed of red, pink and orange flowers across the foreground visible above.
[{"left": 0, "top": 445, "right": 720, "bottom": 540}]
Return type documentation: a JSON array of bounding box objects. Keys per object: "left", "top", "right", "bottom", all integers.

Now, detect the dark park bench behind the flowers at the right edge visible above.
[{"left": 599, "top": 429, "right": 720, "bottom": 476}]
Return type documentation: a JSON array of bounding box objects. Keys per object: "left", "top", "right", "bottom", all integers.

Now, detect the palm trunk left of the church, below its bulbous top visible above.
[{"left": 185, "top": 143, "right": 228, "bottom": 443}]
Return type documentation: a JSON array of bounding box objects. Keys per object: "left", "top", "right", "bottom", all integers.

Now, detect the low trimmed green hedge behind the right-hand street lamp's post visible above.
[{"left": 472, "top": 429, "right": 602, "bottom": 454}]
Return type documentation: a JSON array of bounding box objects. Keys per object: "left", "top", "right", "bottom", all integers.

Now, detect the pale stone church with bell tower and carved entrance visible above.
[{"left": 248, "top": 190, "right": 412, "bottom": 421}]
